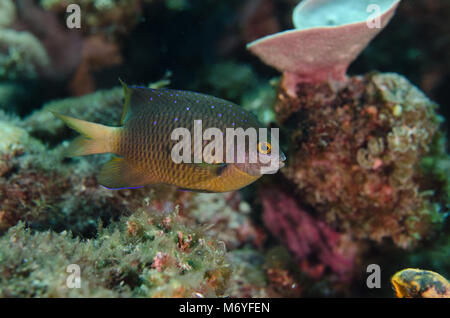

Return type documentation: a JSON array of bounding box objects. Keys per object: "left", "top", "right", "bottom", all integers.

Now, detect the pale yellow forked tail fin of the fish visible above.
[{"left": 52, "top": 111, "right": 120, "bottom": 157}]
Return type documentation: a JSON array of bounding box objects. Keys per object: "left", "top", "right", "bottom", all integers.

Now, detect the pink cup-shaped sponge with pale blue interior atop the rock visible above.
[{"left": 247, "top": 0, "right": 400, "bottom": 82}]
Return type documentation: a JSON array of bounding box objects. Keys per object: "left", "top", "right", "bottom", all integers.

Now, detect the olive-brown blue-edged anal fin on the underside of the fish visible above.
[{"left": 97, "top": 157, "right": 154, "bottom": 190}]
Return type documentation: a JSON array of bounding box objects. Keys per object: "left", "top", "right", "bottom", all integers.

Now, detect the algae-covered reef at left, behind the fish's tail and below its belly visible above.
[{"left": 0, "top": 85, "right": 298, "bottom": 297}]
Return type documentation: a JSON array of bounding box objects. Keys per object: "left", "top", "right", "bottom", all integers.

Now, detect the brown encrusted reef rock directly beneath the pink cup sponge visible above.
[{"left": 275, "top": 74, "right": 448, "bottom": 248}]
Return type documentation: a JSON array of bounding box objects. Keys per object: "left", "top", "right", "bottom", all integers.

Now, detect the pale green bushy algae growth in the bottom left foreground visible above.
[{"left": 0, "top": 210, "right": 232, "bottom": 297}]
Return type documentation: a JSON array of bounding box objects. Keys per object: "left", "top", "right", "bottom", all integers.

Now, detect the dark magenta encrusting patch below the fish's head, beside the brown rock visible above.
[{"left": 261, "top": 188, "right": 357, "bottom": 281}]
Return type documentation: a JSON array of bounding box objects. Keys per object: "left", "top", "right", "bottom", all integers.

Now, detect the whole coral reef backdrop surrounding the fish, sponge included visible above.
[{"left": 0, "top": 0, "right": 450, "bottom": 297}]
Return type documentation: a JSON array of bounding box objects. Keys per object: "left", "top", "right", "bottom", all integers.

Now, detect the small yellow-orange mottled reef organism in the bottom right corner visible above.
[{"left": 391, "top": 268, "right": 450, "bottom": 298}]
